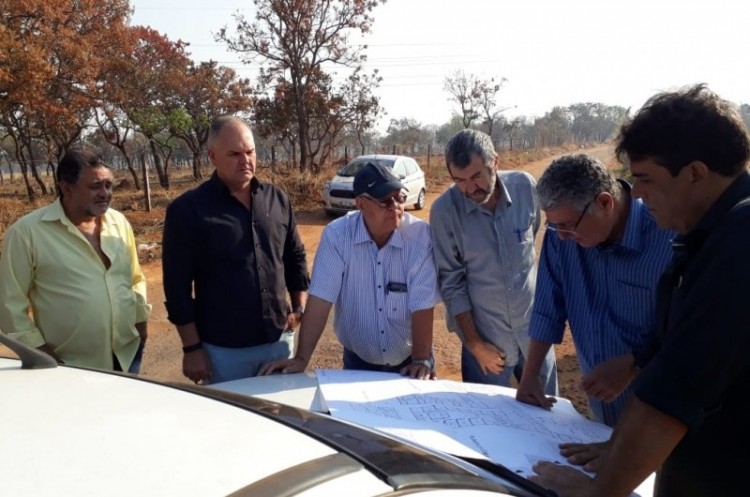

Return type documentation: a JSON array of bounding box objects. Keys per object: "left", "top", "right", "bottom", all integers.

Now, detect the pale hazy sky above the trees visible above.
[{"left": 131, "top": 0, "right": 750, "bottom": 129}]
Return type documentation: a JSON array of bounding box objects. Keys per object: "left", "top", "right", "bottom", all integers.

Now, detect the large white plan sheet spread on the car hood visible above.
[{"left": 317, "top": 370, "right": 652, "bottom": 496}]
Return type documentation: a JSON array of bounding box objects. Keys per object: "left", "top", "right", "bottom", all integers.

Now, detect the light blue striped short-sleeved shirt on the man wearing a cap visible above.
[{"left": 309, "top": 211, "right": 440, "bottom": 365}]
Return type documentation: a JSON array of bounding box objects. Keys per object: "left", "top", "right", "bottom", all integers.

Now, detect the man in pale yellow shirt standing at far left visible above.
[{"left": 0, "top": 149, "right": 151, "bottom": 373}]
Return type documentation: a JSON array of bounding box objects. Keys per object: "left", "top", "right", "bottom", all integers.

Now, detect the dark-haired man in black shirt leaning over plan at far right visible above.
[{"left": 534, "top": 85, "right": 750, "bottom": 497}]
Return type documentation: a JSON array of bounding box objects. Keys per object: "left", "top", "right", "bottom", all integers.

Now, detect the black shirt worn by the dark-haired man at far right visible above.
[{"left": 634, "top": 173, "right": 750, "bottom": 497}]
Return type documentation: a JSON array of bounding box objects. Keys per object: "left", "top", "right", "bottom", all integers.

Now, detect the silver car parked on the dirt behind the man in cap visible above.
[{"left": 323, "top": 155, "right": 427, "bottom": 216}]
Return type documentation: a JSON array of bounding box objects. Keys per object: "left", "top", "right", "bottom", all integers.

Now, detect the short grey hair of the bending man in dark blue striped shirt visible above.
[{"left": 536, "top": 154, "right": 622, "bottom": 211}]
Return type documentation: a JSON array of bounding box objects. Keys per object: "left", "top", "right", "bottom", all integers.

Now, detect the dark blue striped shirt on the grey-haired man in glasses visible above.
[{"left": 529, "top": 192, "right": 674, "bottom": 426}]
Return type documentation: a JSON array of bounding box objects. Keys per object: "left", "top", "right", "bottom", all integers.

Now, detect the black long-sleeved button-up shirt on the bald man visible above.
[{"left": 162, "top": 173, "right": 310, "bottom": 347}]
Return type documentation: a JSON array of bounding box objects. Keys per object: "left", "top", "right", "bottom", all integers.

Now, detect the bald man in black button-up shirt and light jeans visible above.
[{"left": 162, "top": 116, "right": 310, "bottom": 383}]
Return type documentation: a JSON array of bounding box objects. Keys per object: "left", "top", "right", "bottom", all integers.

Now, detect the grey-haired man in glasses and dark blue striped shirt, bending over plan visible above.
[{"left": 516, "top": 155, "right": 673, "bottom": 426}]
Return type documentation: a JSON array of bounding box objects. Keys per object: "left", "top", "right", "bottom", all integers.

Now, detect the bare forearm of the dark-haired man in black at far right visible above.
[{"left": 593, "top": 396, "right": 687, "bottom": 496}]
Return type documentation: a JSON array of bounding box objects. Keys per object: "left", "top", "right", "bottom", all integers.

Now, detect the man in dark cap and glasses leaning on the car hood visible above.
[{"left": 261, "top": 163, "right": 439, "bottom": 379}]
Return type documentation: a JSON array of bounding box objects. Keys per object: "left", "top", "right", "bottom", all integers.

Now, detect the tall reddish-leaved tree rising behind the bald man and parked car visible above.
[{"left": 217, "top": 0, "right": 381, "bottom": 170}]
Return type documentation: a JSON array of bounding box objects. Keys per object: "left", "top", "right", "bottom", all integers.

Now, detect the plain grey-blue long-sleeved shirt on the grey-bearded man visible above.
[{"left": 430, "top": 171, "right": 540, "bottom": 366}]
